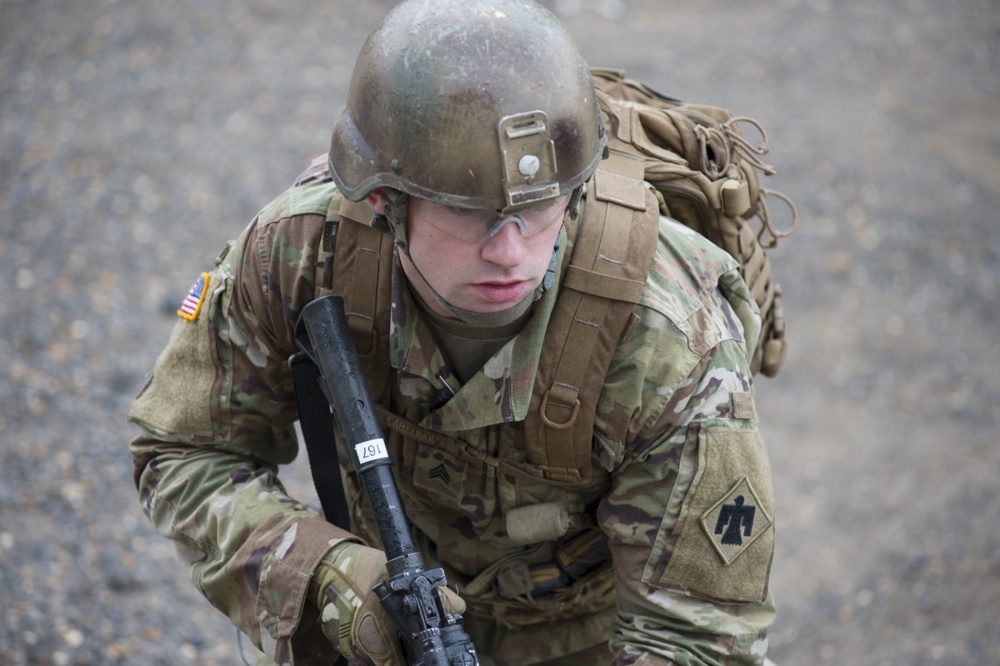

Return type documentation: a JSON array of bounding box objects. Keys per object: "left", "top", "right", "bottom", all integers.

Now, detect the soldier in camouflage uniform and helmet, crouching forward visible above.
[{"left": 129, "top": 0, "right": 774, "bottom": 666}]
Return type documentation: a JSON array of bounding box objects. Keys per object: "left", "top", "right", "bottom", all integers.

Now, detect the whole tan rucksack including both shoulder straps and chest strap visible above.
[{"left": 308, "top": 69, "right": 796, "bottom": 488}]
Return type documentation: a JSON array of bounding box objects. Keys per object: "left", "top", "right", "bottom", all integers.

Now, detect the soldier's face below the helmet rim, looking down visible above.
[{"left": 400, "top": 196, "right": 568, "bottom": 316}]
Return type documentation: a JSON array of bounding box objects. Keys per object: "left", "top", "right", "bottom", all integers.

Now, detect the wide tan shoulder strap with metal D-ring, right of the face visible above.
[{"left": 525, "top": 150, "right": 659, "bottom": 480}]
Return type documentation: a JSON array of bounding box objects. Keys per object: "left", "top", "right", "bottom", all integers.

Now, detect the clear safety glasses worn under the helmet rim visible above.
[{"left": 415, "top": 197, "right": 568, "bottom": 243}]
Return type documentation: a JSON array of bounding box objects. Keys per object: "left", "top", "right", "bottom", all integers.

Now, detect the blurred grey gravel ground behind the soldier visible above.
[{"left": 0, "top": 0, "right": 1000, "bottom": 666}]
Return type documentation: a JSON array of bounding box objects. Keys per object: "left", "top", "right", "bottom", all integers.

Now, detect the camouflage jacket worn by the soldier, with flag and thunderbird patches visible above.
[{"left": 129, "top": 156, "right": 774, "bottom": 665}]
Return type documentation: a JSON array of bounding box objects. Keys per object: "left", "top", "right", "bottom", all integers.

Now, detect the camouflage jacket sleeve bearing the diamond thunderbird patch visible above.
[{"left": 598, "top": 268, "right": 774, "bottom": 666}]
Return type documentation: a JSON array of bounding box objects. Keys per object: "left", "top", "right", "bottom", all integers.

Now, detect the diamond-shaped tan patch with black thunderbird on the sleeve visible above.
[{"left": 701, "top": 477, "right": 772, "bottom": 566}]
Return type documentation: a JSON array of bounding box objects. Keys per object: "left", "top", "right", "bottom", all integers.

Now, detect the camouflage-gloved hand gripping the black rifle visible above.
[{"left": 310, "top": 542, "right": 465, "bottom": 666}]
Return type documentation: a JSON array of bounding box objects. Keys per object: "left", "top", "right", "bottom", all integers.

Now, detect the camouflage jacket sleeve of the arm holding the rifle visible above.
[{"left": 129, "top": 204, "right": 354, "bottom": 664}]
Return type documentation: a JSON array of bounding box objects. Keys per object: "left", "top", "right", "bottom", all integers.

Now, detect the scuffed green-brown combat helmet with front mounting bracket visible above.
[{"left": 330, "top": 0, "right": 606, "bottom": 212}]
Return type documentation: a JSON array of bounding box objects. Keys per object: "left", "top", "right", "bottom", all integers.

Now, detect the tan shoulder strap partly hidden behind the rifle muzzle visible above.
[{"left": 331, "top": 195, "right": 392, "bottom": 397}]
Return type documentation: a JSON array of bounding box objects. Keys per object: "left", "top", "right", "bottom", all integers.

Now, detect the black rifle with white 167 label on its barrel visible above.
[{"left": 295, "top": 295, "right": 479, "bottom": 666}]
